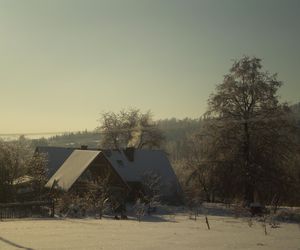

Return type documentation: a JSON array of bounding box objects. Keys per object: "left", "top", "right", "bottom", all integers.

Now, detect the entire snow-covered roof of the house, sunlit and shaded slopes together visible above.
[{"left": 37, "top": 147, "right": 180, "bottom": 195}]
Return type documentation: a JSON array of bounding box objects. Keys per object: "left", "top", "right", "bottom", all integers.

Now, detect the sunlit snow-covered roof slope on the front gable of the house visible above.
[{"left": 46, "top": 150, "right": 101, "bottom": 191}]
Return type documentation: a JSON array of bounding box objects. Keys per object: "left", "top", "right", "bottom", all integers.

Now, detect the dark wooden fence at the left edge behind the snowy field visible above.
[{"left": 0, "top": 201, "right": 54, "bottom": 219}]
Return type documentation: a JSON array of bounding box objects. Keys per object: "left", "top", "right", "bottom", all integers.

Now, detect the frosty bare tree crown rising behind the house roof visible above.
[{"left": 100, "top": 108, "right": 164, "bottom": 149}]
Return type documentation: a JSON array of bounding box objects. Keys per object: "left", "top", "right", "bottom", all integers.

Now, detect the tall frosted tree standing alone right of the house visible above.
[{"left": 207, "top": 56, "right": 294, "bottom": 203}]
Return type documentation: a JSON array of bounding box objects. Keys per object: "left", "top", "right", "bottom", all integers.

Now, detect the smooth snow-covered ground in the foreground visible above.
[{"left": 0, "top": 214, "right": 300, "bottom": 250}]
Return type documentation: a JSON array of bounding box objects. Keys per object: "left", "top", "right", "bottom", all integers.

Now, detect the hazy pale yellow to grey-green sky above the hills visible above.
[{"left": 0, "top": 0, "right": 300, "bottom": 134}]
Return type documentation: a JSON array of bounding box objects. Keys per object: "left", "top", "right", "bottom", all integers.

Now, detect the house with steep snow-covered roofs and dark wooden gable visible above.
[{"left": 36, "top": 147, "right": 181, "bottom": 201}]
